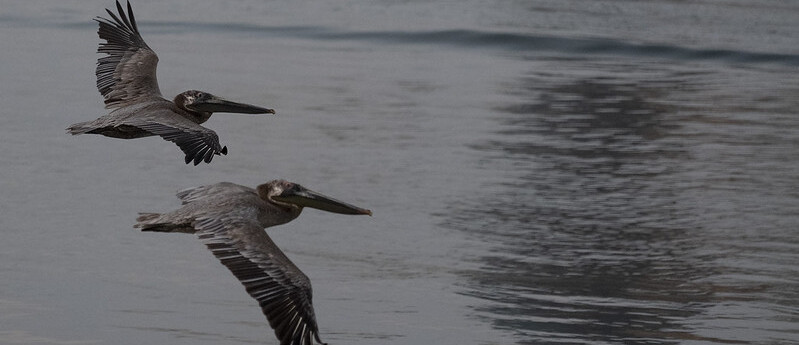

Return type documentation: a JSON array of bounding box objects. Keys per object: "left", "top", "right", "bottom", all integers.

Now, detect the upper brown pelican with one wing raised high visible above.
[{"left": 67, "top": 1, "right": 275, "bottom": 165}]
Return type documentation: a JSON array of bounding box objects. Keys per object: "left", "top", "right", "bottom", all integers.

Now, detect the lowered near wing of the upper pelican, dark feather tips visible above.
[{"left": 125, "top": 109, "right": 227, "bottom": 165}]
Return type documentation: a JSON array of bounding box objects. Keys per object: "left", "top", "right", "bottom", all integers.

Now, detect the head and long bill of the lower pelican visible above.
[{"left": 258, "top": 180, "right": 372, "bottom": 216}]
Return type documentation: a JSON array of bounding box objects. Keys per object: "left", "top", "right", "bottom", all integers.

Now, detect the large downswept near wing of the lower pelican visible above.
[{"left": 194, "top": 214, "right": 322, "bottom": 345}]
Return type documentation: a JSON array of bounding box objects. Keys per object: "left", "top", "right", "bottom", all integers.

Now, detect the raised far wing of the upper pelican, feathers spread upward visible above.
[{"left": 95, "top": 1, "right": 161, "bottom": 109}]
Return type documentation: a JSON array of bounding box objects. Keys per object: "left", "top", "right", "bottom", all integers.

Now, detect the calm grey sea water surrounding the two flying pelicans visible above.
[{"left": 0, "top": 0, "right": 799, "bottom": 344}]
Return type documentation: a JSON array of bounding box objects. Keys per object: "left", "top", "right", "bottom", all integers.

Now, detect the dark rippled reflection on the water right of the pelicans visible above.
[{"left": 446, "top": 68, "right": 760, "bottom": 344}]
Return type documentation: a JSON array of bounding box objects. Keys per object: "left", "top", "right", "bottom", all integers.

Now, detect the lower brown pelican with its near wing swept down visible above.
[{"left": 134, "top": 180, "right": 372, "bottom": 345}]
